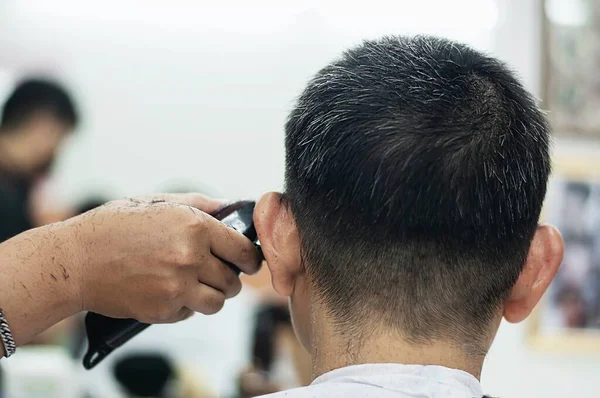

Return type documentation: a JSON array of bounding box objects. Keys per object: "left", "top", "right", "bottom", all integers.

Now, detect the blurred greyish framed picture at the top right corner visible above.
[{"left": 542, "top": 0, "right": 600, "bottom": 139}]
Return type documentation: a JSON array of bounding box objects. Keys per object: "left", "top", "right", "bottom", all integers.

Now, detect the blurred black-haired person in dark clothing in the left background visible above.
[{"left": 0, "top": 79, "right": 79, "bottom": 242}]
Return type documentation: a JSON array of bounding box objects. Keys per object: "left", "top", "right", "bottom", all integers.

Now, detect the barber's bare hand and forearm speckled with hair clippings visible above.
[{"left": 0, "top": 194, "right": 261, "bottom": 354}]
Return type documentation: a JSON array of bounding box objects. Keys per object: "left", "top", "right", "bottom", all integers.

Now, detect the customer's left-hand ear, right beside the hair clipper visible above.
[{"left": 254, "top": 192, "right": 304, "bottom": 296}]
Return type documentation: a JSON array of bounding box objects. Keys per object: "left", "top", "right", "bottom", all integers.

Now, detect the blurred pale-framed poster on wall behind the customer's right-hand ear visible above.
[{"left": 531, "top": 159, "right": 600, "bottom": 352}]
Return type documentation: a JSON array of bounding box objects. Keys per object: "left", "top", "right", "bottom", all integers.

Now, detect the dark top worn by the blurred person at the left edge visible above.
[{"left": 0, "top": 174, "right": 33, "bottom": 242}]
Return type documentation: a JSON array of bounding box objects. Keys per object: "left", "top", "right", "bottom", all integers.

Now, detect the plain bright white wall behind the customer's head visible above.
[{"left": 0, "top": 0, "right": 600, "bottom": 398}]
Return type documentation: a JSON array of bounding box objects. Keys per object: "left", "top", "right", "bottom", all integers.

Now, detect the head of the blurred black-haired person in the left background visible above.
[{"left": 0, "top": 79, "right": 78, "bottom": 177}]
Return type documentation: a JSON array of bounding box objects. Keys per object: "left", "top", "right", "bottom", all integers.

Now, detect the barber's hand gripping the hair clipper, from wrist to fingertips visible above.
[{"left": 65, "top": 194, "right": 260, "bottom": 323}]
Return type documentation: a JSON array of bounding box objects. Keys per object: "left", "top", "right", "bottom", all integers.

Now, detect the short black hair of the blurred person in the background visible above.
[{"left": 1, "top": 78, "right": 78, "bottom": 128}]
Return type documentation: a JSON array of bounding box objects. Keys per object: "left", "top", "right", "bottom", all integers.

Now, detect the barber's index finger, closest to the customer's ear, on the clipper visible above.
[{"left": 206, "top": 217, "right": 262, "bottom": 275}]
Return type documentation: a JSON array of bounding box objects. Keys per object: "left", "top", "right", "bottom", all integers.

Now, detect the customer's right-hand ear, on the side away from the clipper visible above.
[{"left": 504, "top": 225, "right": 564, "bottom": 323}]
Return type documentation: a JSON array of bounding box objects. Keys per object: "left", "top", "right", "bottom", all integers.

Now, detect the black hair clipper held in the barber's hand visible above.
[{"left": 83, "top": 201, "right": 260, "bottom": 369}]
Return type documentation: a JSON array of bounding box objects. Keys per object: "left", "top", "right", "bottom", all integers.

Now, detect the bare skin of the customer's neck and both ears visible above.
[{"left": 254, "top": 192, "right": 564, "bottom": 378}]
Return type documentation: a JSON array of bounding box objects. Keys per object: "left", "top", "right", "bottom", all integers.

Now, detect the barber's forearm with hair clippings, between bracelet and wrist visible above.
[{"left": 0, "top": 224, "right": 81, "bottom": 354}]
